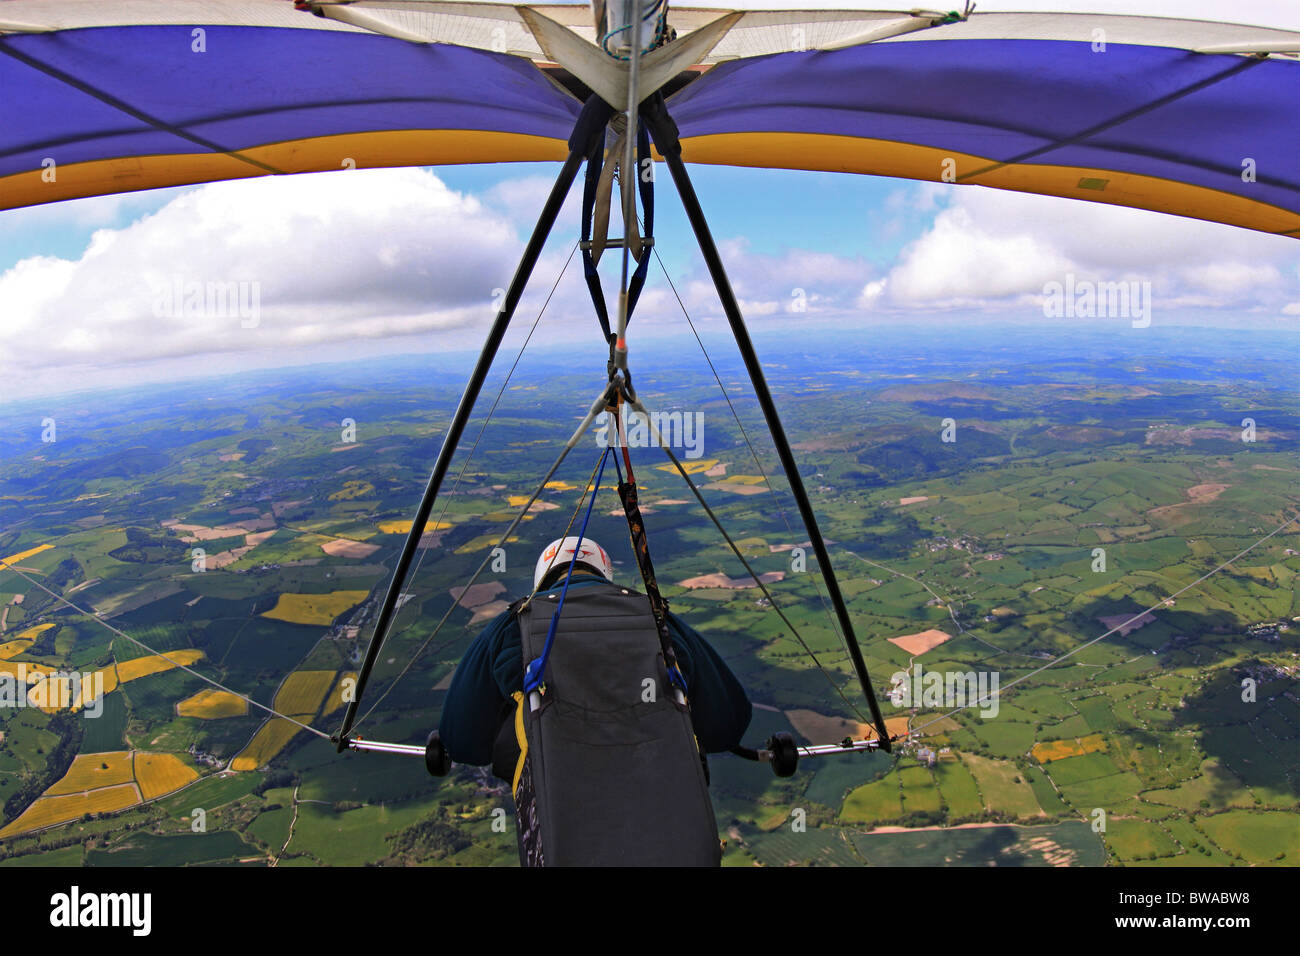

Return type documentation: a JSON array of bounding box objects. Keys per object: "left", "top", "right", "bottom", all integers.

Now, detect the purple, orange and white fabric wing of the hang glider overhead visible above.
[{"left": 0, "top": 0, "right": 1300, "bottom": 235}]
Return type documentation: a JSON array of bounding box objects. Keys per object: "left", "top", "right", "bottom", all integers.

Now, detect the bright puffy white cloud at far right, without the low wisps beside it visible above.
[{"left": 857, "top": 187, "right": 1300, "bottom": 321}]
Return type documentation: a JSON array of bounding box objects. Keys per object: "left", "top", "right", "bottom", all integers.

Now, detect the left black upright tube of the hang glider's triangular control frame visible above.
[{"left": 335, "top": 96, "right": 614, "bottom": 753}]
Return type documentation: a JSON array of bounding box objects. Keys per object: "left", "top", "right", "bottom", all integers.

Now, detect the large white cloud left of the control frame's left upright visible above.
[{"left": 0, "top": 169, "right": 569, "bottom": 369}]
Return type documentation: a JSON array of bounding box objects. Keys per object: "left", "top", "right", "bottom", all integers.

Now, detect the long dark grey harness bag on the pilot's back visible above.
[{"left": 514, "top": 583, "right": 722, "bottom": 866}]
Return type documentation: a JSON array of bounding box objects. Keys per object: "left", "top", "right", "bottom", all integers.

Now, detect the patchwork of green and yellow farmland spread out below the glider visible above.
[{"left": 0, "top": 330, "right": 1300, "bottom": 866}]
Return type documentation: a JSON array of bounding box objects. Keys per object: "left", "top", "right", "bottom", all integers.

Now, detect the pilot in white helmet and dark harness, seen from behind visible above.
[{"left": 438, "top": 537, "right": 751, "bottom": 865}]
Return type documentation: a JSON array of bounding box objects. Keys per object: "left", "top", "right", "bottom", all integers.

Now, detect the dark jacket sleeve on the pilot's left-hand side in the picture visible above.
[{"left": 438, "top": 611, "right": 523, "bottom": 766}]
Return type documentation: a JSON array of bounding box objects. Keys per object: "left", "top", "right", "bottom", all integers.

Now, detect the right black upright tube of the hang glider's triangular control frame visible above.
[{"left": 641, "top": 94, "right": 891, "bottom": 753}]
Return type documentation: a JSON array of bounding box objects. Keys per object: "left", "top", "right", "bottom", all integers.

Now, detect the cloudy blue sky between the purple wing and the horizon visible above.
[{"left": 0, "top": 0, "right": 1300, "bottom": 401}]
